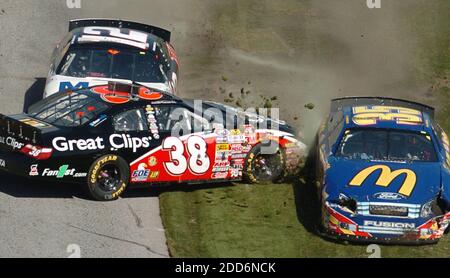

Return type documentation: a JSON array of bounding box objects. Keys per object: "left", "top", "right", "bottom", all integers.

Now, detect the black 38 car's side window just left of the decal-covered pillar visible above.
[{"left": 114, "top": 109, "right": 148, "bottom": 132}]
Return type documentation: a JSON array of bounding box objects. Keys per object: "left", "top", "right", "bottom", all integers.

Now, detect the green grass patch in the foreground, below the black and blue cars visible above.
[{"left": 160, "top": 180, "right": 450, "bottom": 258}]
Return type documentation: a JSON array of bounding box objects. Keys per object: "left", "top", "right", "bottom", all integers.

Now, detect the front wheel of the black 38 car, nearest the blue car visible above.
[{"left": 242, "top": 141, "right": 286, "bottom": 184}]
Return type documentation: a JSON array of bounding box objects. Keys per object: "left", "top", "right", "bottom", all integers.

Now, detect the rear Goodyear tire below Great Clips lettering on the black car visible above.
[{"left": 85, "top": 154, "right": 130, "bottom": 201}]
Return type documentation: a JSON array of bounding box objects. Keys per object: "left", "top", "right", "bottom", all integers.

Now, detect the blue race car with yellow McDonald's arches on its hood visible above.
[{"left": 315, "top": 97, "right": 450, "bottom": 244}]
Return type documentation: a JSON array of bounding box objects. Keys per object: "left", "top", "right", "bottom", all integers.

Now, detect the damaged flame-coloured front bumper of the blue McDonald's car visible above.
[{"left": 322, "top": 203, "right": 450, "bottom": 245}]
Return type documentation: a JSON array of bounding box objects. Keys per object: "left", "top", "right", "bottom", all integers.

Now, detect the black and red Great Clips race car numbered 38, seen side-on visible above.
[{"left": 0, "top": 83, "right": 305, "bottom": 200}]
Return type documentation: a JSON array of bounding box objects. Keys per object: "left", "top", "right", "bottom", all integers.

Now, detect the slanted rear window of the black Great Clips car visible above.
[{"left": 28, "top": 92, "right": 109, "bottom": 127}]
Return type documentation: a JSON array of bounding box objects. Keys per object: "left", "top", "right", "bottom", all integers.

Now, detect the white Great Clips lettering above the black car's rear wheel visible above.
[{"left": 52, "top": 134, "right": 152, "bottom": 152}]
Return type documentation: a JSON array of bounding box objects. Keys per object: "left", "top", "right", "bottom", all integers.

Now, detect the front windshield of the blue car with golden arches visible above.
[{"left": 336, "top": 129, "right": 437, "bottom": 162}]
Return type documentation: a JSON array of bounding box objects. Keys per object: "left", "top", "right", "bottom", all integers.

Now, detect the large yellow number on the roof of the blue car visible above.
[{"left": 353, "top": 106, "right": 423, "bottom": 126}]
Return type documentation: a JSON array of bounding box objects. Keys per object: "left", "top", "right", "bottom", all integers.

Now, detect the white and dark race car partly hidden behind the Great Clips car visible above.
[{"left": 44, "top": 19, "right": 179, "bottom": 98}]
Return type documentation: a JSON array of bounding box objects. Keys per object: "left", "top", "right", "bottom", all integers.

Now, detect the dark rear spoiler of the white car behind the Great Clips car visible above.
[{"left": 69, "top": 18, "right": 171, "bottom": 42}]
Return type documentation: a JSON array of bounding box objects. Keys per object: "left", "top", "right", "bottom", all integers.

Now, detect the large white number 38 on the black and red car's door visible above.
[{"left": 162, "top": 136, "right": 211, "bottom": 176}]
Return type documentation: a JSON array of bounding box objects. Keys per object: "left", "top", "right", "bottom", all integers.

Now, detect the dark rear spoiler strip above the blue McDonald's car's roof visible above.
[{"left": 331, "top": 97, "right": 434, "bottom": 119}]
